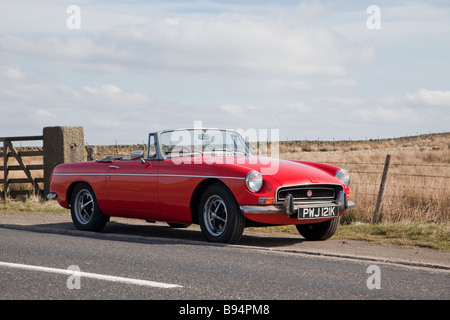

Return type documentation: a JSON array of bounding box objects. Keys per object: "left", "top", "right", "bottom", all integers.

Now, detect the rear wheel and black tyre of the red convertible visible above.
[{"left": 70, "top": 183, "right": 109, "bottom": 231}]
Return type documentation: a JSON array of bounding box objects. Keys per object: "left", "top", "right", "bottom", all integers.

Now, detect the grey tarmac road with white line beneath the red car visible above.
[{"left": 0, "top": 214, "right": 450, "bottom": 311}]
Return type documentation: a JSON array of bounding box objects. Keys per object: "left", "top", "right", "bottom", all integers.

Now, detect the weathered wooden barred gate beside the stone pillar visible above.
[{"left": 0, "top": 136, "right": 44, "bottom": 198}]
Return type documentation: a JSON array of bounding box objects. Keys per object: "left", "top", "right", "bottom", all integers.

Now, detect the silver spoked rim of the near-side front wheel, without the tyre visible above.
[{"left": 203, "top": 195, "right": 228, "bottom": 236}]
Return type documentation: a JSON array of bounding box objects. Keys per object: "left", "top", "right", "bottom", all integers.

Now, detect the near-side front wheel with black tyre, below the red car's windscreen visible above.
[{"left": 199, "top": 184, "right": 245, "bottom": 243}]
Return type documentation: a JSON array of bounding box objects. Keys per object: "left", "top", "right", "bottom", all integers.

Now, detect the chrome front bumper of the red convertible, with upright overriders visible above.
[{"left": 240, "top": 191, "right": 355, "bottom": 217}]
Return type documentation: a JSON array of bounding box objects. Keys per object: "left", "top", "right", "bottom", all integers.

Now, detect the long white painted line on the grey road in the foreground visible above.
[{"left": 0, "top": 261, "right": 182, "bottom": 289}]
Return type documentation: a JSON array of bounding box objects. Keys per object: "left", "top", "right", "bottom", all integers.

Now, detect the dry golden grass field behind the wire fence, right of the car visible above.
[{"left": 280, "top": 133, "right": 450, "bottom": 223}]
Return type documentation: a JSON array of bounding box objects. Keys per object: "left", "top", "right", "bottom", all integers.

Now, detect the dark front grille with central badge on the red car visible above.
[{"left": 277, "top": 185, "right": 342, "bottom": 202}]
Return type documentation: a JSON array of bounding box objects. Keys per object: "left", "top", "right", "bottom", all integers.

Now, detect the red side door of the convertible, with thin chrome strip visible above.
[{"left": 106, "top": 159, "right": 159, "bottom": 218}]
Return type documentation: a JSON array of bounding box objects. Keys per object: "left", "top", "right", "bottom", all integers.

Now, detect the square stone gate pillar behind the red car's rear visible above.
[{"left": 43, "top": 127, "right": 85, "bottom": 195}]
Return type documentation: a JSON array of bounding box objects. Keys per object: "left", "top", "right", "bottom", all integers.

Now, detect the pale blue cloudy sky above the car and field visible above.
[{"left": 0, "top": 0, "right": 450, "bottom": 145}]
